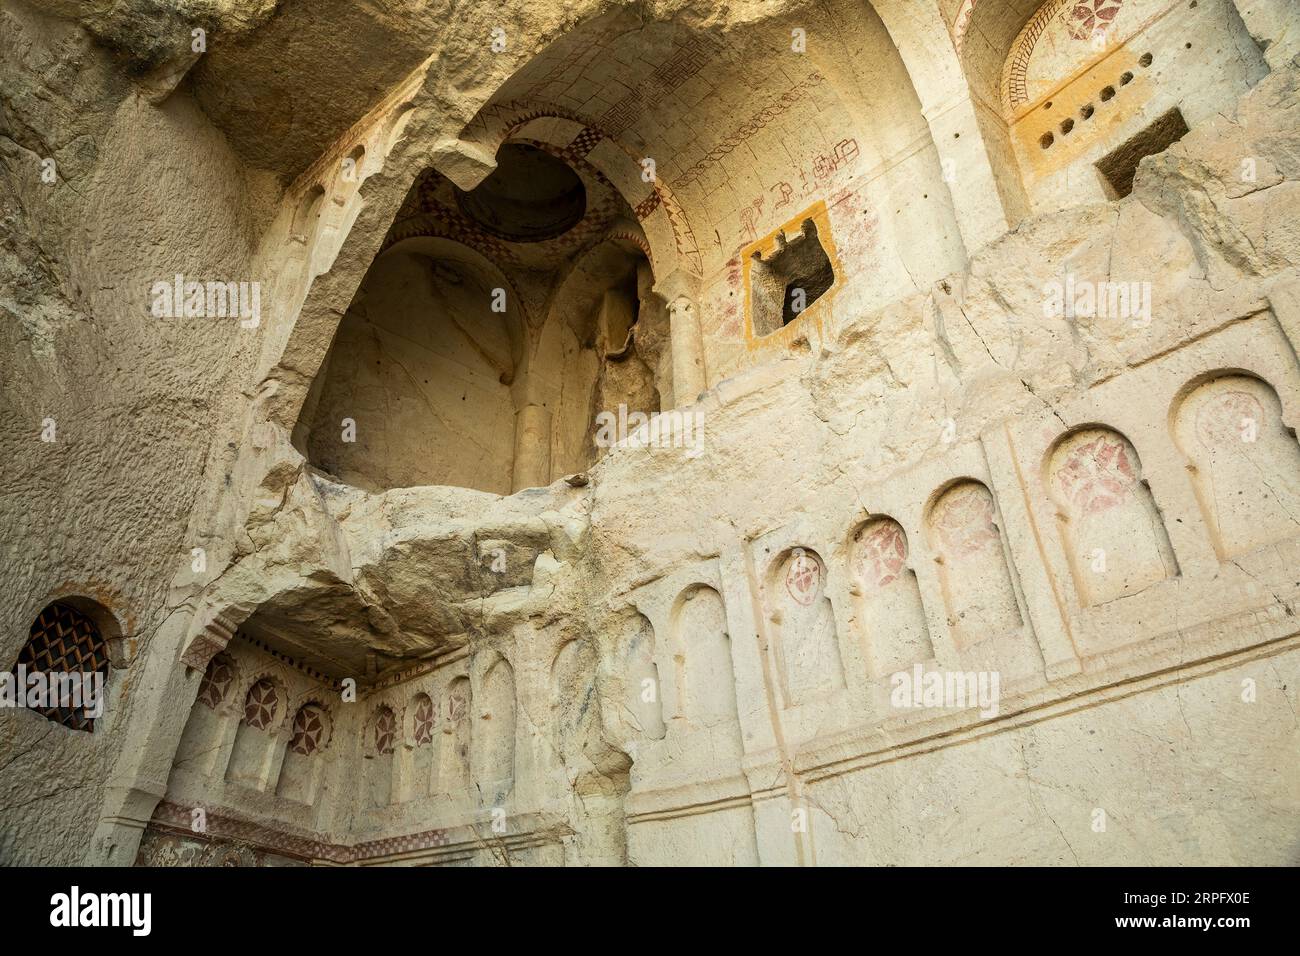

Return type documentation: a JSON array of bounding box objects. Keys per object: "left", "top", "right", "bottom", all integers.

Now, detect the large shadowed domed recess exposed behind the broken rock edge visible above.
[{"left": 294, "top": 135, "right": 668, "bottom": 494}]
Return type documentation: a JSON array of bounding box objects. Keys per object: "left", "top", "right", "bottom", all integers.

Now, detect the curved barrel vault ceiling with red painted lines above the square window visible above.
[{"left": 462, "top": 0, "right": 928, "bottom": 283}]
